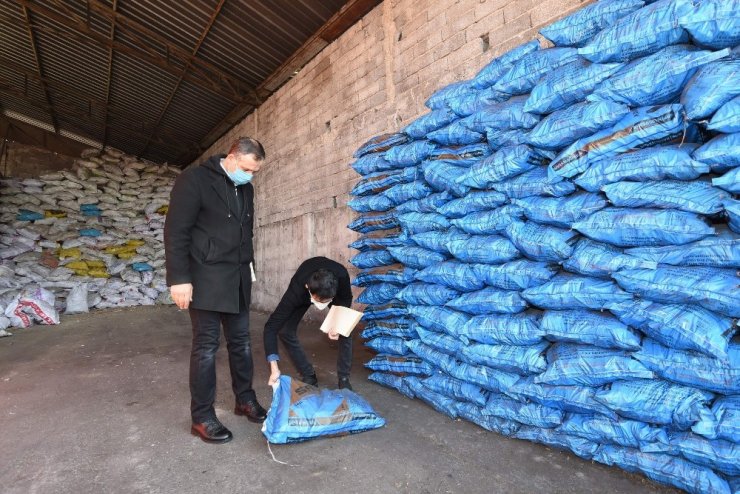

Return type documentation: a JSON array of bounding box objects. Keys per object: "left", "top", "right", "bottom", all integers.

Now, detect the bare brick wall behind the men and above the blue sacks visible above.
[{"left": 199, "top": 0, "right": 588, "bottom": 310}]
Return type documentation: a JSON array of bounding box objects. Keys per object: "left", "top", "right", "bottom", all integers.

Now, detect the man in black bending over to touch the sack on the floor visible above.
[{"left": 264, "top": 257, "right": 352, "bottom": 389}]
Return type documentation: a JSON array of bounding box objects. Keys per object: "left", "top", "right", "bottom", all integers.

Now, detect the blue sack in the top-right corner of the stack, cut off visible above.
[{"left": 678, "top": 0, "right": 740, "bottom": 50}]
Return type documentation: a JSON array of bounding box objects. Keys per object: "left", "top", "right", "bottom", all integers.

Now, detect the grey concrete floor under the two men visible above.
[{"left": 0, "top": 307, "right": 676, "bottom": 494}]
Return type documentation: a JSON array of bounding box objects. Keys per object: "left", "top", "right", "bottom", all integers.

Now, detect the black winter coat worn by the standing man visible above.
[{"left": 164, "top": 156, "right": 254, "bottom": 314}]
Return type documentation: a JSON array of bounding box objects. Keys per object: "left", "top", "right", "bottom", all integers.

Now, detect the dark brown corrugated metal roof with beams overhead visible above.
[{"left": 0, "top": 0, "right": 380, "bottom": 166}]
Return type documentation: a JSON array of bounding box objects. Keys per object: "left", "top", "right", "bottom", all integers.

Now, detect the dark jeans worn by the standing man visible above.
[{"left": 190, "top": 288, "right": 256, "bottom": 423}]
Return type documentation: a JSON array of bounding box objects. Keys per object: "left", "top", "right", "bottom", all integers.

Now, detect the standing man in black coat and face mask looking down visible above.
[{"left": 164, "top": 137, "right": 267, "bottom": 443}]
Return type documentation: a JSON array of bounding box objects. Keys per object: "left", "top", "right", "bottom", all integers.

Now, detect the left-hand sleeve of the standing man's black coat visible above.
[{"left": 164, "top": 172, "right": 201, "bottom": 286}]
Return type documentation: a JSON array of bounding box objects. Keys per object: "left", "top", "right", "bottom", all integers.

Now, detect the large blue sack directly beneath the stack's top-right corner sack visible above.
[{"left": 586, "top": 45, "right": 730, "bottom": 107}]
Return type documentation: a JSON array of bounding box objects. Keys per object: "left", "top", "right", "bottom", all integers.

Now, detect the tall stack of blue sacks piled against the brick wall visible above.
[{"left": 349, "top": 0, "right": 740, "bottom": 493}]
